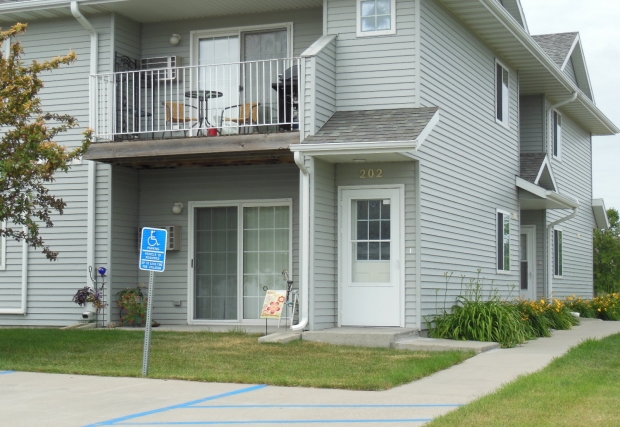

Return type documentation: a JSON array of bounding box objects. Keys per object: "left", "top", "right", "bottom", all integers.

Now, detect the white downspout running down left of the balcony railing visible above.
[{"left": 71, "top": 1, "right": 99, "bottom": 283}]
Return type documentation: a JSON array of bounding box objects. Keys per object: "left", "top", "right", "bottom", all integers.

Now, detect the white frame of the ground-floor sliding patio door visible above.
[{"left": 187, "top": 198, "right": 294, "bottom": 326}]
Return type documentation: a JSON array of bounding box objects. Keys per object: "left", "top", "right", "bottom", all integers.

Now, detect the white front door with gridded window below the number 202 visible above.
[{"left": 340, "top": 188, "right": 404, "bottom": 327}]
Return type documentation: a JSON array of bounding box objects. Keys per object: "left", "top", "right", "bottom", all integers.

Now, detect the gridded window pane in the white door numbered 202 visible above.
[{"left": 351, "top": 199, "right": 391, "bottom": 283}]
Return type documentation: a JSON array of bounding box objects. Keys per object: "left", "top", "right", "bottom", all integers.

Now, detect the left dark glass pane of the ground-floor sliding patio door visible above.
[{"left": 194, "top": 207, "right": 237, "bottom": 320}]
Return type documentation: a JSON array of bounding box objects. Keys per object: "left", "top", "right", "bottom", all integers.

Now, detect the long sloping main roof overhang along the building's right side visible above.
[{"left": 439, "top": 0, "right": 620, "bottom": 135}]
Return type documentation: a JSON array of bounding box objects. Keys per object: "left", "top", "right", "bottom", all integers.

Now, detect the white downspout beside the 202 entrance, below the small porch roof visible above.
[{"left": 291, "top": 151, "right": 311, "bottom": 331}]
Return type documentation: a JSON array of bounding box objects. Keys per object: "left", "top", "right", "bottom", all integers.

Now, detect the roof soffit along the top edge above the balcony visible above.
[{"left": 0, "top": 0, "right": 323, "bottom": 23}]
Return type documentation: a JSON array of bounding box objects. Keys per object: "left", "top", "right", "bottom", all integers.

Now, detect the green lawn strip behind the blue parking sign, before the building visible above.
[{"left": 0, "top": 329, "right": 473, "bottom": 390}]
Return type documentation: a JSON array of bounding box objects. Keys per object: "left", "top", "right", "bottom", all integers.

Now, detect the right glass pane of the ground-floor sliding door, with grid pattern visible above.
[{"left": 243, "top": 206, "right": 290, "bottom": 319}]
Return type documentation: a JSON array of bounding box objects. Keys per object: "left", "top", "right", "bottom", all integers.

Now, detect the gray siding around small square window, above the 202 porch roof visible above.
[{"left": 327, "top": 0, "right": 419, "bottom": 111}]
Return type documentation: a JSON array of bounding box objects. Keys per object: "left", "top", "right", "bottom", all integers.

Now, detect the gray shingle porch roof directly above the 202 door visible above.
[{"left": 304, "top": 107, "right": 439, "bottom": 144}]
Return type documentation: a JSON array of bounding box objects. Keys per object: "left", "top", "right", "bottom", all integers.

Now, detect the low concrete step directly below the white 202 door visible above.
[{"left": 301, "top": 328, "right": 418, "bottom": 348}]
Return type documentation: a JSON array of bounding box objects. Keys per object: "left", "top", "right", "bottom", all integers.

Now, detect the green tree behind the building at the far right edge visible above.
[{"left": 594, "top": 208, "right": 620, "bottom": 294}]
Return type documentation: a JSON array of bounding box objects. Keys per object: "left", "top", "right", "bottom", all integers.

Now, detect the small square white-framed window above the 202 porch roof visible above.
[{"left": 357, "top": 0, "right": 396, "bottom": 37}]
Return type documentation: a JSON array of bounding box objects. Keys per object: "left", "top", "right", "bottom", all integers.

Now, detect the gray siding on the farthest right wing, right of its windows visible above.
[{"left": 547, "top": 107, "right": 596, "bottom": 297}]
